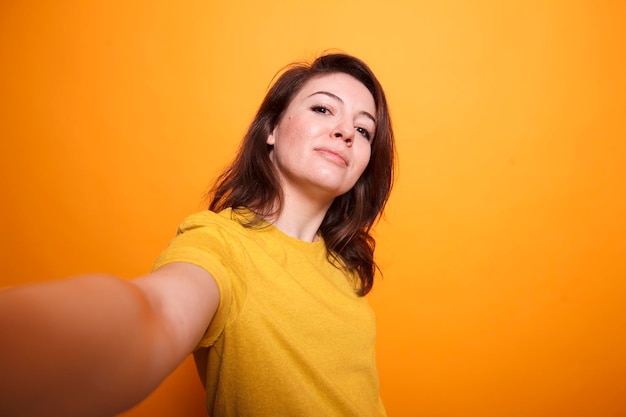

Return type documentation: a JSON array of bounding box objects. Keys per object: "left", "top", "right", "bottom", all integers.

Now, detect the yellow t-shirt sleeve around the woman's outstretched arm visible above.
[{"left": 153, "top": 211, "right": 237, "bottom": 347}]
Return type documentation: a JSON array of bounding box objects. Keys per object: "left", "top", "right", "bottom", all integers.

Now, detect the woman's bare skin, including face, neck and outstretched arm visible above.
[{"left": 0, "top": 74, "right": 376, "bottom": 417}]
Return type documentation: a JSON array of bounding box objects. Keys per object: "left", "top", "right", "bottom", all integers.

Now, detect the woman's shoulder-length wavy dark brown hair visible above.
[{"left": 208, "top": 53, "right": 395, "bottom": 295}]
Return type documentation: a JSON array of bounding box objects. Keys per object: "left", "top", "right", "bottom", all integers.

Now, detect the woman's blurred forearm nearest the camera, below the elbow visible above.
[{"left": 0, "top": 276, "right": 174, "bottom": 417}]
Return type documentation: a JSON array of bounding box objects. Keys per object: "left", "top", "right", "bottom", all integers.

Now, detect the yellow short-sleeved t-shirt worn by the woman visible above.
[{"left": 155, "top": 209, "right": 386, "bottom": 417}]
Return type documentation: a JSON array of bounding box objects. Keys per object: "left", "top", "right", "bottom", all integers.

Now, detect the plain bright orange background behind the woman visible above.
[{"left": 0, "top": 0, "right": 626, "bottom": 417}]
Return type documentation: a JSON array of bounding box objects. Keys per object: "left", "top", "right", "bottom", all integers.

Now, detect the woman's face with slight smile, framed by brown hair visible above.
[{"left": 267, "top": 73, "right": 376, "bottom": 203}]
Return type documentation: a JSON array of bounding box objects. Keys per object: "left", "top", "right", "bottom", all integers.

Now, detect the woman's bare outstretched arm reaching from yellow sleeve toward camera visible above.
[{"left": 0, "top": 263, "right": 219, "bottom": 417}]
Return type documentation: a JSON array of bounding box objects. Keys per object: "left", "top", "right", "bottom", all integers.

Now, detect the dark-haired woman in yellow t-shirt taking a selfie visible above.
[{"left": 0, "top": 54, "right": 394, "bottom": 417}]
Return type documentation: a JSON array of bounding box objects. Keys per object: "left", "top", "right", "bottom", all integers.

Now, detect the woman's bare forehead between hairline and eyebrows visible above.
[{"left": 294, "top": 72, "right": 376, "bottom": 112}]
